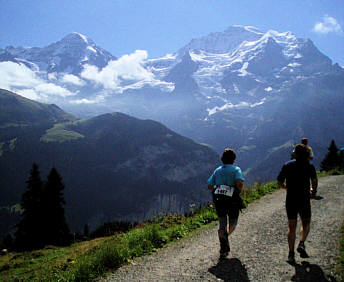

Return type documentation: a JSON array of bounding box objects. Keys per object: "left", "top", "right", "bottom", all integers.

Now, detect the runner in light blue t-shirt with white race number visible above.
[{"left": 208, "top": 149, "right": 245, "bottom": 257}]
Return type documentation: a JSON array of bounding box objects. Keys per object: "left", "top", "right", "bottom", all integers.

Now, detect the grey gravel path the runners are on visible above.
[{"left": 103, "top": 176, "right": 344, "bottom": 281}]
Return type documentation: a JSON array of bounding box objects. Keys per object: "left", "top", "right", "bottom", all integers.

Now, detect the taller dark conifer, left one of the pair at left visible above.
[{"left": 15, "top": 163, "right": 44, "bottom": 250}]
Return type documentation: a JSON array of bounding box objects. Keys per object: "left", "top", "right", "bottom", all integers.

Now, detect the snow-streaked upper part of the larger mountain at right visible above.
[{"left": 147, "top": 26, "right": 332, "bottom": 106}]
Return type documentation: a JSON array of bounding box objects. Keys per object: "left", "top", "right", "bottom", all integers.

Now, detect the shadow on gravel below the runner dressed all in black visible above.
[{"left": 291, "top": 261, "right": 337, "bottom": 282}]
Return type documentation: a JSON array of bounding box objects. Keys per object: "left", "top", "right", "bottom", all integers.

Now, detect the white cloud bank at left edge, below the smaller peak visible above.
[{"left": 0, "top": 62, "right": 74, "bottom": 101}]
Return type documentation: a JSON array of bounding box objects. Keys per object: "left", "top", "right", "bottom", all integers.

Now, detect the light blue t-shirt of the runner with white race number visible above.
[{"left": 208, "top": 164, "right": 245, "bottom": 187}]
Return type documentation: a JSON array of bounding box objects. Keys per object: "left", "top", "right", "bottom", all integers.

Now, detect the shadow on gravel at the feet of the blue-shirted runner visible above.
[{"left": 208, "top": 258, "right": 250, "bottom": 281}]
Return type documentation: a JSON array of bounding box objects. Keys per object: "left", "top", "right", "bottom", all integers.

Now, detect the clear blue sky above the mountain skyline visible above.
[{"left": 0, "top": 0, "right": 344, "bottom": 66}]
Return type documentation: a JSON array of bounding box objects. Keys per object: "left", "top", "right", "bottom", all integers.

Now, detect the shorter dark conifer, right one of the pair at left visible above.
[{"left": 42, "top": 168, "right": 70, "bottom": 245}]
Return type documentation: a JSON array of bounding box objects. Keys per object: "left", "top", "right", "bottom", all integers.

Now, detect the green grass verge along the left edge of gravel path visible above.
[{"left": 0, "top": 182, "right": 278, "bottom": 281}]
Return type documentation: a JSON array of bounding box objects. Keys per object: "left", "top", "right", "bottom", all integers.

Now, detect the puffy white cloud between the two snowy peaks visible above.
[{"left": 81, "top": 50, "right": 173, "bottom": 93}]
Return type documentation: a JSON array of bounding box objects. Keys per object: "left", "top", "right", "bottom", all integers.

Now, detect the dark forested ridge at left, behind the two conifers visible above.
[{"left": 0, "top": 90, "right": 219, "bottom": 236}]
